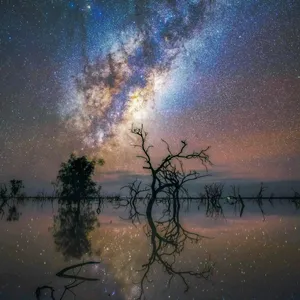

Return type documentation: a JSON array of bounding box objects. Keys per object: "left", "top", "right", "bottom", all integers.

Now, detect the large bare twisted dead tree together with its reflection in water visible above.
[{"left": 128, "top": 126, "right": 213, "bottom": 299}]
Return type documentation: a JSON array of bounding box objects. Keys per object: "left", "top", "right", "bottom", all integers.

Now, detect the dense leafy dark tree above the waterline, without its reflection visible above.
[{"left": 56, "top": 153, "right": 104, "bottom": 202}]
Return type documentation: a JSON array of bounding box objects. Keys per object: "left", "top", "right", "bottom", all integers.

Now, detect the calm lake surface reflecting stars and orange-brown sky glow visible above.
[{"left": 0, "top": 202, "right": 300, "bottom": 300}]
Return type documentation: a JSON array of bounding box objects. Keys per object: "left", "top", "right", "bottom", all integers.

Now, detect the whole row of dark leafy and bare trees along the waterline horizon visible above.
[{"left": 0, "top": 126, "right": 300, "bottom": 220}]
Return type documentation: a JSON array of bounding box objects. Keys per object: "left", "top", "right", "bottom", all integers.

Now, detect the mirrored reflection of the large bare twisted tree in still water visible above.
[{"left": 117, "top": 181, "right": 214, "bottom": 300}]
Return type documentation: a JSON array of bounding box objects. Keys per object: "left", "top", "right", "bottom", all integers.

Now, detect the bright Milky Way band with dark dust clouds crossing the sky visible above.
[{"left": 59, "top": 1, "right": 217, "bottom": 147}]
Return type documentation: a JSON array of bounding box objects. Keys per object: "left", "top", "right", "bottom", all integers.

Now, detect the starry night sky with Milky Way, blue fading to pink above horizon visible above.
[{"left": 0, "top": 0, "right": 300, "bottom": 192}]
